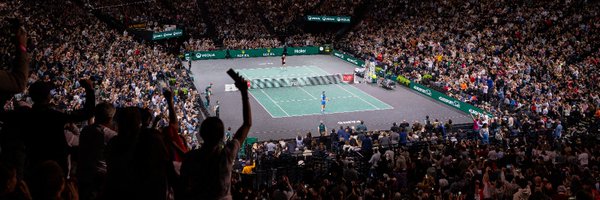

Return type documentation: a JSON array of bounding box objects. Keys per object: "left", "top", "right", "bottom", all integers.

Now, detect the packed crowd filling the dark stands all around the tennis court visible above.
[{"left": 0, "top": 1, "right": 600, "bottom": 200}]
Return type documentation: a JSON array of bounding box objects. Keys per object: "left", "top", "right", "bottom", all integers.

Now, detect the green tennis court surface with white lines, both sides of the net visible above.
[{"left": 236, "top": 65, "right": 393, "bottom": 118}]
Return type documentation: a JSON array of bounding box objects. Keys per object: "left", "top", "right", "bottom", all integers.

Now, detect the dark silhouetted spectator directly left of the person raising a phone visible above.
[{"left": 103, "top": 107, "right": 176, "bottom": 200}]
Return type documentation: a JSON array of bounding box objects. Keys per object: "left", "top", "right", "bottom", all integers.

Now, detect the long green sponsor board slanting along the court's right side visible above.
[{"left": 410, "top": 82, "right": 492, "bottom": 117}]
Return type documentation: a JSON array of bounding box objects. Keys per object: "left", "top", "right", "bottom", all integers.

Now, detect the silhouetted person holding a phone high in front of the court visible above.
[{"left": 181, "top": 69, "right": 252, "bottom": 199}]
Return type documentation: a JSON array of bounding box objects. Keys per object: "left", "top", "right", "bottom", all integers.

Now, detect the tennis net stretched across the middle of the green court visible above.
[{"left": 249, "top": 74, "right": 343, "bottom": 89}]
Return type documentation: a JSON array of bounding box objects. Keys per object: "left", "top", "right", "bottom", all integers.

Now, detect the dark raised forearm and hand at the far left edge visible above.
[{"left": 0, "top": 27, "right": 29, "bottom": 93}]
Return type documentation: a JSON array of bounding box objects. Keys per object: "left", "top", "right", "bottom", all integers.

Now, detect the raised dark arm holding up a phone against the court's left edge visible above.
[{"left": 227, "top": 69, "right": 252, "bottom": 144}]
